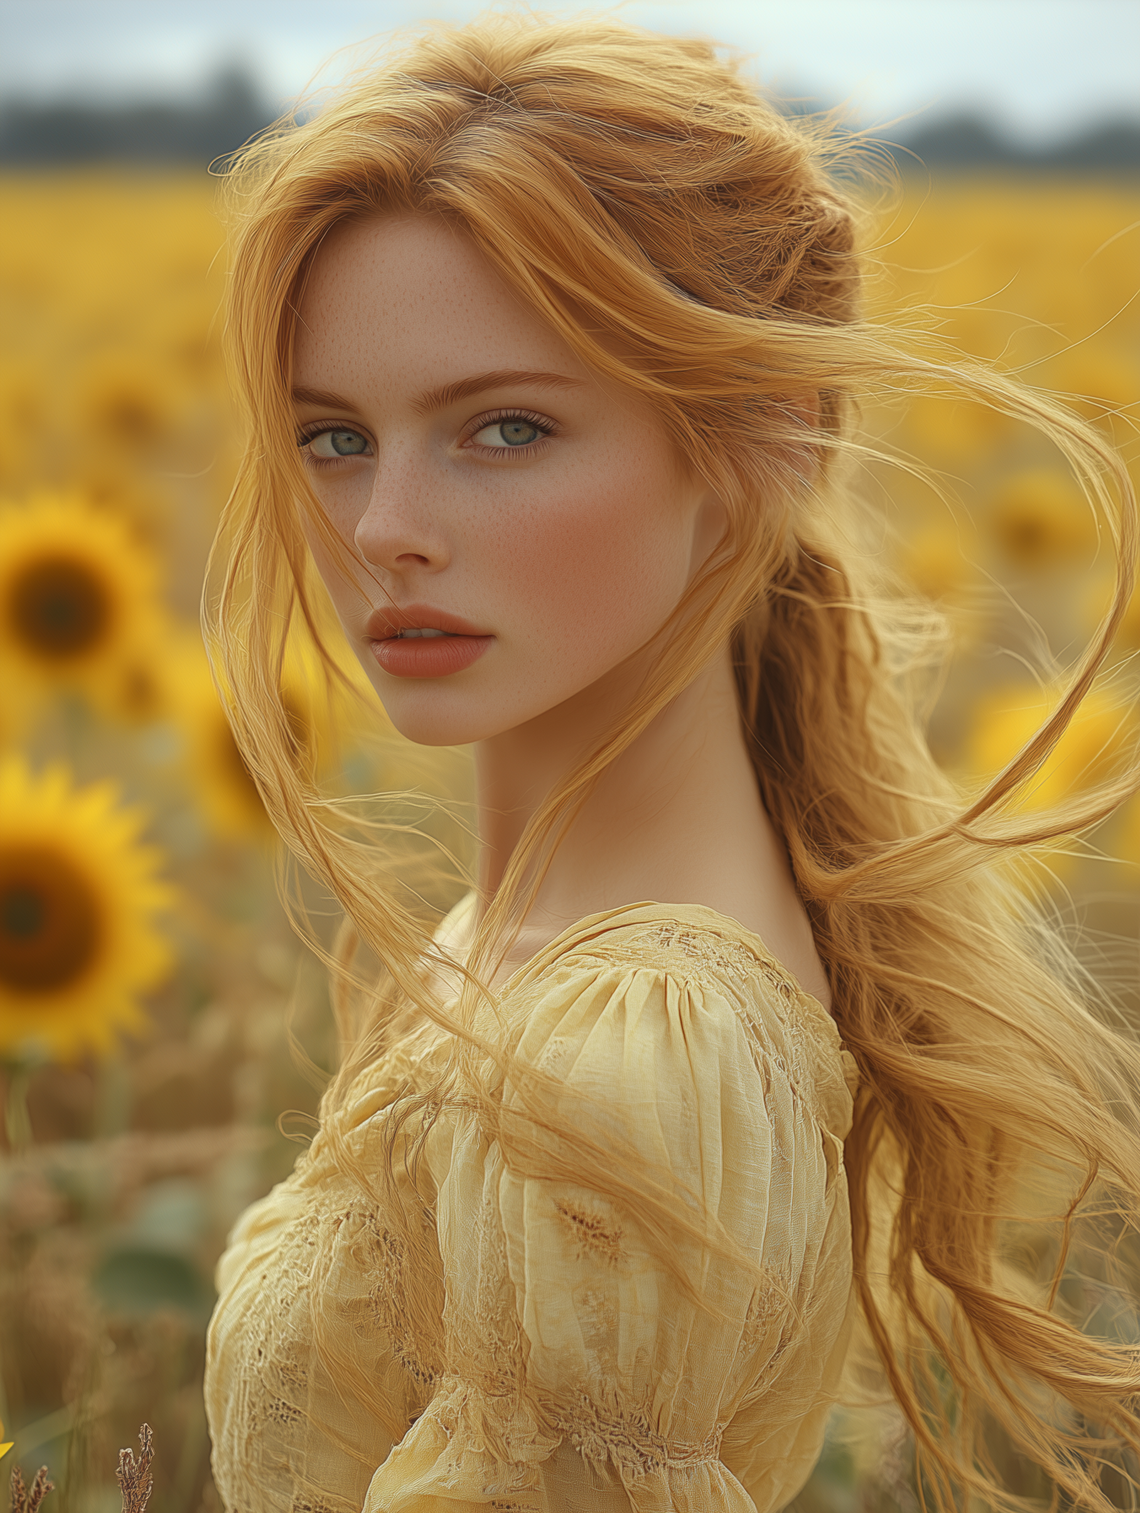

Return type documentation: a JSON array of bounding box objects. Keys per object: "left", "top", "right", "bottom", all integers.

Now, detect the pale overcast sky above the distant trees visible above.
[{"left": 0, "top": 0, "right": 1140, "bottom": 142}]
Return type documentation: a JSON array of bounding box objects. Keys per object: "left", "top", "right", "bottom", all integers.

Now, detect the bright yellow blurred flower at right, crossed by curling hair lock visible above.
[{"left": 967, "top": 684, "right": 1135, "bottom": 809}]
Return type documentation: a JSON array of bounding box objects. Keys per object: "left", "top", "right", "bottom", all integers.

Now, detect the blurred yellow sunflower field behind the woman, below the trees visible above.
[{"left": 0, "top": 171, "right": 1140, "bottom": 1513}]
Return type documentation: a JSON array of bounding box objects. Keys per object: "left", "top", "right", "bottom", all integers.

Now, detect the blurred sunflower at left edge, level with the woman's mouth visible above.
[{"left": 0, "top": 495, "right": 162, "bottom": 704}]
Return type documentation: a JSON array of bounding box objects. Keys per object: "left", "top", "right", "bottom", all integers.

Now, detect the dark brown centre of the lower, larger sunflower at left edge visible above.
[{"left": 0, "top": 846, "right": 103, "bottom": 993}]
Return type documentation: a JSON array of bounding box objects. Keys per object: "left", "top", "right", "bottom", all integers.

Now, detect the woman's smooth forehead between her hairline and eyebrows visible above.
[{"left": 294, "top": 215, "right": 589, "bottom": 402}]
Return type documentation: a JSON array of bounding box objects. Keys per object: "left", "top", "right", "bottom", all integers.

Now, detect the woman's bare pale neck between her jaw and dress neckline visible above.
[{"left": 475, "top": 646, "right": 830, "bottom": 1005}]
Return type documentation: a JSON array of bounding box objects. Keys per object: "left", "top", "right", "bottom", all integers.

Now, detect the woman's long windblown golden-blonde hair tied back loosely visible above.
[{"left": 206, "top": 17, "right": 1140, "bottom": 1508}]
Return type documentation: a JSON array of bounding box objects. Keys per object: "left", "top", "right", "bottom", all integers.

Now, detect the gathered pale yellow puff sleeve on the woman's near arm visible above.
[{"left": 363, "top": 953, "right": 851, "bottom": 1513}]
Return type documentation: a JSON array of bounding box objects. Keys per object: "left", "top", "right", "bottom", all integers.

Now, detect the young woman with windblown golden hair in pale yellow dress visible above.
[{"left": 207, "top": 18, "right": 1140, "bottom": 1513}]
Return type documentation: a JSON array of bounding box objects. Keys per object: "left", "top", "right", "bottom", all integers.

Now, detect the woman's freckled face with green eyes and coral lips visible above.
[{"left": 294, "top": 216, "right": 722, "bottom": 744}]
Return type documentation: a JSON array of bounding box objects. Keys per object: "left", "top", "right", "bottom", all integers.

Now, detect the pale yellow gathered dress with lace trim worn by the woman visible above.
[{"left": 206, "top": 896, "right": 855, "bottom": 1513}]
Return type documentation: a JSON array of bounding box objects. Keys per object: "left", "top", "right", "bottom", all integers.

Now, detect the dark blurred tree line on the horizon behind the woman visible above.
[{"left": 0, "top": 67, "right": 1140, "bottom": 174}]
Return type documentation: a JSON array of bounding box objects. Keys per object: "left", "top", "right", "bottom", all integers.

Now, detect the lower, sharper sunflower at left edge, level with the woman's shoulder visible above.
[{"left": 0, "top": 757, "right": 173, "bottom": 1061}]
